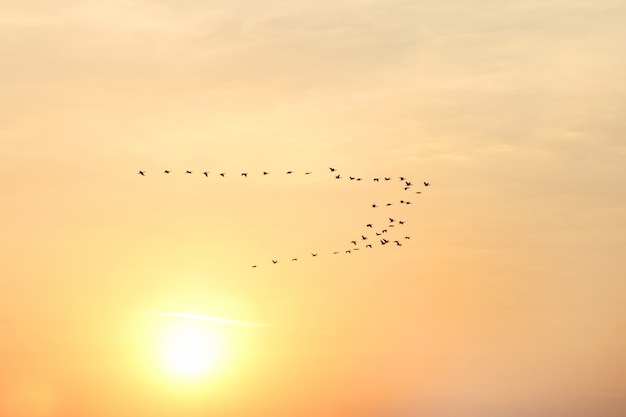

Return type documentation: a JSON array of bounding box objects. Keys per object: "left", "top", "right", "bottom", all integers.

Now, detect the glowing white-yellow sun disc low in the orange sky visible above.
[{"left": 158, "top": 323, "right": 222, "bottom": 380}]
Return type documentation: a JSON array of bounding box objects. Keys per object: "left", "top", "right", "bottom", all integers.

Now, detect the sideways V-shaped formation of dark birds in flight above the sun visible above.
[{"left": 137, "top": 167, "right": 430, "bottom": 268}]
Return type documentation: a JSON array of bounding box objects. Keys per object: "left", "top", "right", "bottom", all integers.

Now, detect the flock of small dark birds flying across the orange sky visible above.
[{"left": 137, "top": 167, "right": 430, "bottom": 268}]
